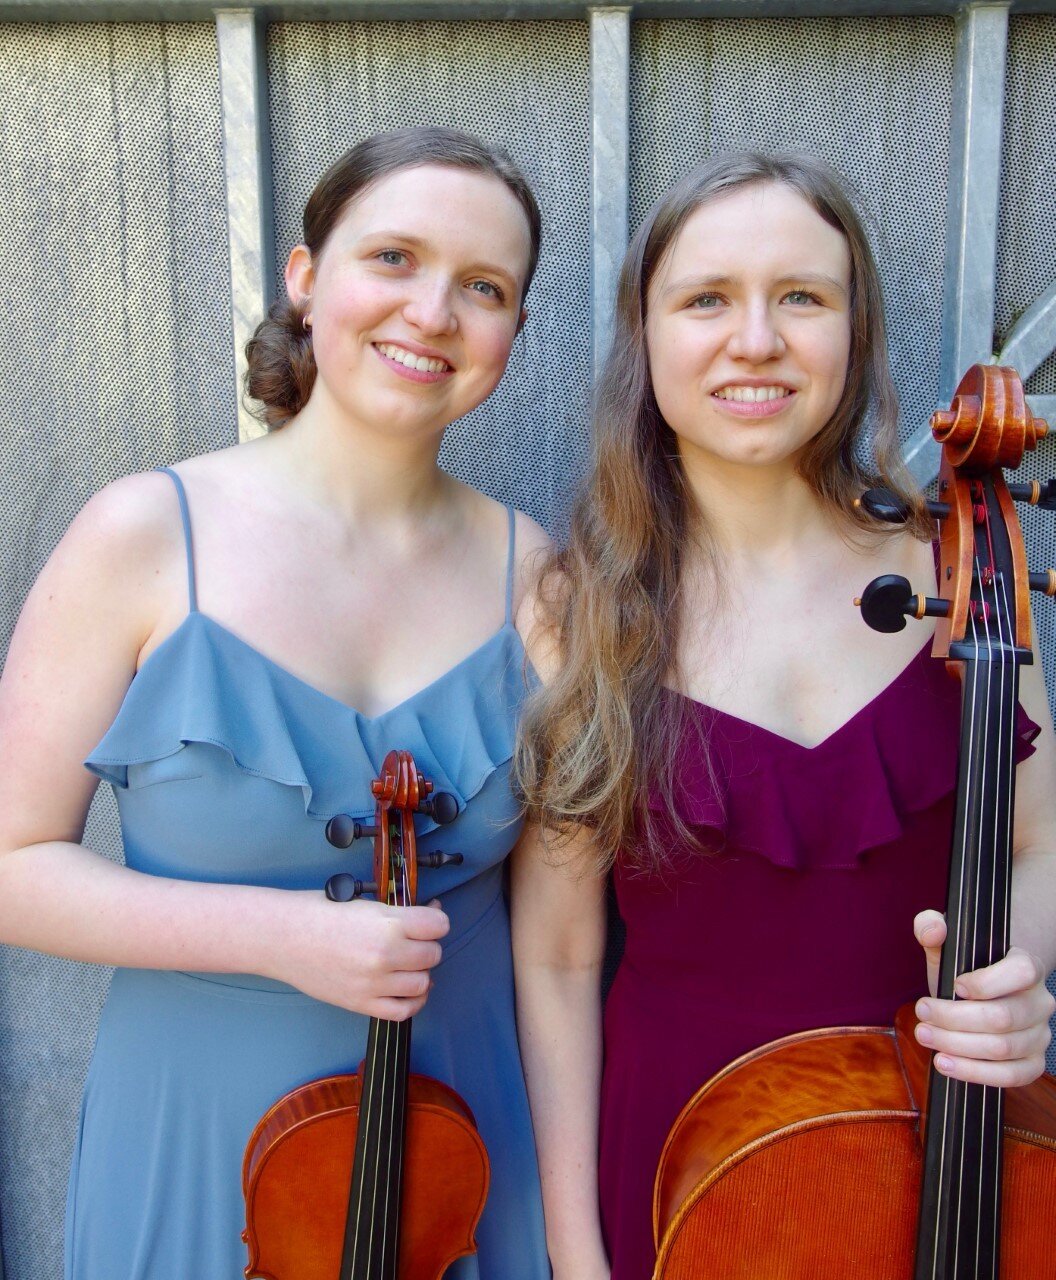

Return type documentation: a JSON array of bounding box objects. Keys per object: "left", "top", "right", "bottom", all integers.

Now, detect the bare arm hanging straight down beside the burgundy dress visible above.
[{"left": 511, "top": 828, "right": 609, "bottom": 1280}]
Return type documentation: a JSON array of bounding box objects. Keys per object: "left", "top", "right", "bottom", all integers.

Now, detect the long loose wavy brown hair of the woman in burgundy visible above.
[{"left": 516, "top": 151, "right": 927, "bottom": 870}]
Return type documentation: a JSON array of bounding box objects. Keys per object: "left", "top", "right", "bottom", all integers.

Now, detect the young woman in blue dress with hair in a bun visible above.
[{"left": 0, "top": 128, "right": 549, "bottom": 1280}]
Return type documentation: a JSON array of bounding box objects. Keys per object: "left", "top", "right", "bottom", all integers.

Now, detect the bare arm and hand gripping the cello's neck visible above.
[{"left": 914, "top": 650, "right": 1056, "bottom": 1085}]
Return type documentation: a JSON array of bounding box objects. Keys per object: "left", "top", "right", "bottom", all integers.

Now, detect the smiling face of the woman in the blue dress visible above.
[{"left": 287, "top": 165, "right": 530, "bottom": 435}]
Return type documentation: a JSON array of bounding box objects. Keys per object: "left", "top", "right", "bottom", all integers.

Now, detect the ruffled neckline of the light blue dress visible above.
[{"left": 84, "top": 611, "right": 529, "bottom": 833}]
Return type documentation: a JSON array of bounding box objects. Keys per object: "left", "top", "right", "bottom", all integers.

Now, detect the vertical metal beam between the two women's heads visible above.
[{"left": 590, "top": 6, "right": 631, "bottom": 374}]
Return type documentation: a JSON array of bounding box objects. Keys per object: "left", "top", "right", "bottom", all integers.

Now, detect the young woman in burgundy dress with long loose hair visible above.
[{"left": 512, "top": 154, "right": 1056, "bottom": 1280}]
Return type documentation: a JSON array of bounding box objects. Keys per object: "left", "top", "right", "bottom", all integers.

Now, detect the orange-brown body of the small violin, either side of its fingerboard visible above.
[{"left": 242, "top": 1070, "right": 489, "bottom": 1280}]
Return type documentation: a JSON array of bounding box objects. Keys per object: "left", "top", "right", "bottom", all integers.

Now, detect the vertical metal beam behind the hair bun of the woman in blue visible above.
[{"left": 216, "top": 9, "right": 273, "bottom": 440}]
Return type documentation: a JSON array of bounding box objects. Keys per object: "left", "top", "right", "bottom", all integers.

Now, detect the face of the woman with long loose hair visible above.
[{"left": 645, "top": 182, "right": 851, "bottom": 478}]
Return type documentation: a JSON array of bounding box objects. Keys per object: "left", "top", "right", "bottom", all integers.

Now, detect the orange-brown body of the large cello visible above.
[{"left": 653, "top": 1006, "right": 1056, "bottom": 1280}]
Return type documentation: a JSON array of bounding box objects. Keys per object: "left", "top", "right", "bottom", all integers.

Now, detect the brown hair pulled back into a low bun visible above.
[{"left": 246, "top": 125, "right": 543, "bottom": 430}]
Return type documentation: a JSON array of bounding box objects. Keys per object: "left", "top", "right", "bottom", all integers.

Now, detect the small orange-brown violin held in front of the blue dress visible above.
[{"left": 242, "top": 751, "right": 490, "bottom": 1280}]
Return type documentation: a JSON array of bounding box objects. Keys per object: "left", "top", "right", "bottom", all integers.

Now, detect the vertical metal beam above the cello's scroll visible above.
[{"left": 906, "top": 0, "right": 1009, "bottom": 481}]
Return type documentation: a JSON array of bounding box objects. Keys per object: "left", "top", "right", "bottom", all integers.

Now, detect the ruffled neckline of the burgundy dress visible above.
[{"left": 649, "top": 641, "right": 1041, "bottom": 870}]
